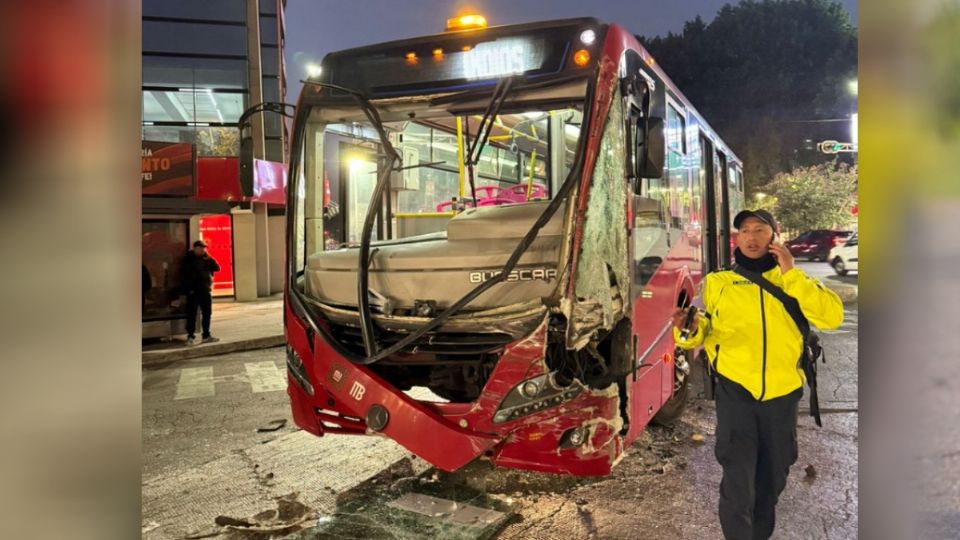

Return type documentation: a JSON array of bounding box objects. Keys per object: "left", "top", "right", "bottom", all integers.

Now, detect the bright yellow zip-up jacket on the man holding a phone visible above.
[{"left": 674, "top": 266, "right": 843, "bottom": 401}]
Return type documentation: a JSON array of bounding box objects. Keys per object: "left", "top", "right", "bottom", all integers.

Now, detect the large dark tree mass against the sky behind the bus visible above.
[{"left": 638, "top": 0, "right": 857, "bottom": 194}]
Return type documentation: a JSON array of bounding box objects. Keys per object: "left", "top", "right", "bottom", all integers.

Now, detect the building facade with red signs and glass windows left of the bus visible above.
[{"left": 141, "top": 0, "right": 288, "bottom": 337}]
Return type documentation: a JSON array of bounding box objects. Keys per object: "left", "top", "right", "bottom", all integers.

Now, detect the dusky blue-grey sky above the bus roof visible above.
[{"left": 285, "top": 0, "right": 857, "bottom": 103}]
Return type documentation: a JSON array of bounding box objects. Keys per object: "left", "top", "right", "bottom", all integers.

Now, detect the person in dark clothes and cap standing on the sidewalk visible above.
[{"left": 180, "top": 240, "right": 220, "bottom": 345}]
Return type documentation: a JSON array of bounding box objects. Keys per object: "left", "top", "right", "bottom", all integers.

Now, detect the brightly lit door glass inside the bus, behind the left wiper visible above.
[{"left": 340, "top": 144, "right": 389, "bottom": 244}]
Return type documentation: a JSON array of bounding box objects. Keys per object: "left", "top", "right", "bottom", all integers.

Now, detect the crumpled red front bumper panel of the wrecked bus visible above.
[{"left": 287, "top": 310, "right": 622, "bottom": 476}]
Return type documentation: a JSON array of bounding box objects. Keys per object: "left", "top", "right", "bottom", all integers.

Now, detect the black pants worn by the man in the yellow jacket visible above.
[{"left": 714, "top": 377, "right": 803, "bottom": 540}]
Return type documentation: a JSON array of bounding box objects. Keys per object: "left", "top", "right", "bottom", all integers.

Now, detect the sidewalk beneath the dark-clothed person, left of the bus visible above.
[{"left": 142, "top": 294, "right": 284, "bottom": 365}]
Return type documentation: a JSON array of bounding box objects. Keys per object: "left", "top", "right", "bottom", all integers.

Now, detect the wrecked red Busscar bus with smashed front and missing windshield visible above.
[{"left": 241, "top": 15, "right": 743, "bottom": 475}]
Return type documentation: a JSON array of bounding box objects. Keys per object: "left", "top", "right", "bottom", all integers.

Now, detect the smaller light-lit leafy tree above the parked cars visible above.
[{"left": 754, "top": 163, "right": 857, "bottom": 231}]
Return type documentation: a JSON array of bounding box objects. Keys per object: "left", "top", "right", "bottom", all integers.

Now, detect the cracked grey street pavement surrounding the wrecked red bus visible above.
[{"left": 142, "top": 306, "right": 858, "bottom": 540}]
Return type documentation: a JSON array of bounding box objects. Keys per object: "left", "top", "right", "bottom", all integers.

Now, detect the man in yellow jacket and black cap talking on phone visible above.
[{"left": 674, "top": 210, "right": 843, "bottom": 540}]
